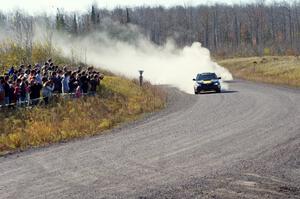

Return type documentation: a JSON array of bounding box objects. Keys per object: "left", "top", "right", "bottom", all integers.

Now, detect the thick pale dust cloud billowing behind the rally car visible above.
[{"left": 48, "top": 21, "right": 232, "bottom": 93}]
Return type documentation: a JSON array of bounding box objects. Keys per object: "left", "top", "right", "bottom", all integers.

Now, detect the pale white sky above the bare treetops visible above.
[{"left": 0, "top": 0, "right": 274, "bottom": 13}]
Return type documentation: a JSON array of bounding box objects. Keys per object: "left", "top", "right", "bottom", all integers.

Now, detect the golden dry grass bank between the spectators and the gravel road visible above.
[{"left": 0, "top": 76, "right": 165, "bottom": 154}]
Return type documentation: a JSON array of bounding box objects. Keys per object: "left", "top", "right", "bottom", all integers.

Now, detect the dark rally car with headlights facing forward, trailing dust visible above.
[{"left": 193, "top": 73, "right": 221, "bottom": 94}]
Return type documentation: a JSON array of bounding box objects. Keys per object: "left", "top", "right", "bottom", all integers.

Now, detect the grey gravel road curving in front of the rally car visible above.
[{"left": 0, "top": 81, "right": 300, "bottom": 199}]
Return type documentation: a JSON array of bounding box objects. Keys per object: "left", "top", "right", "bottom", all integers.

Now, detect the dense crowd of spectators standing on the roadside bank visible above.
[{"left": 0, "top": 59, "right": 103, "bottom": 106}]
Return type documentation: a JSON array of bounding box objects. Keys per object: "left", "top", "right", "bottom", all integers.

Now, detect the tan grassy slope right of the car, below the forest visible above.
[{"left": 218, "top": 56, "right": 300, "bottom": 87}]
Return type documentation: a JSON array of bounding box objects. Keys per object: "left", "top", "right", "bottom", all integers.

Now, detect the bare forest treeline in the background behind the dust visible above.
[{"left": 0, "top": 1, "right": 300, "bottom": 56}]
